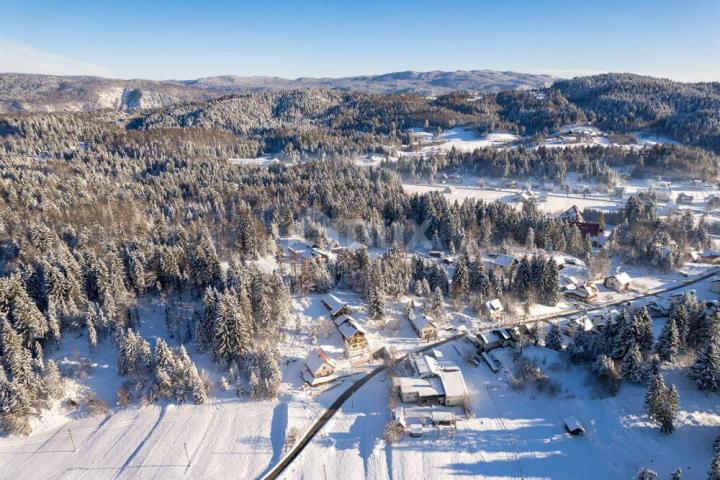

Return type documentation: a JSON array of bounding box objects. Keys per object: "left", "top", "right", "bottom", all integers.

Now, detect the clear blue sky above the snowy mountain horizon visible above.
[{"left": 0, "top": 0, "right": 720, "bottom": 81}]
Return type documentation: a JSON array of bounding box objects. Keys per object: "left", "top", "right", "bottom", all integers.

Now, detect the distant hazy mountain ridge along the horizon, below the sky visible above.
[{"left": 0, "top": 70, "right": 554, "bottom": 113}]
